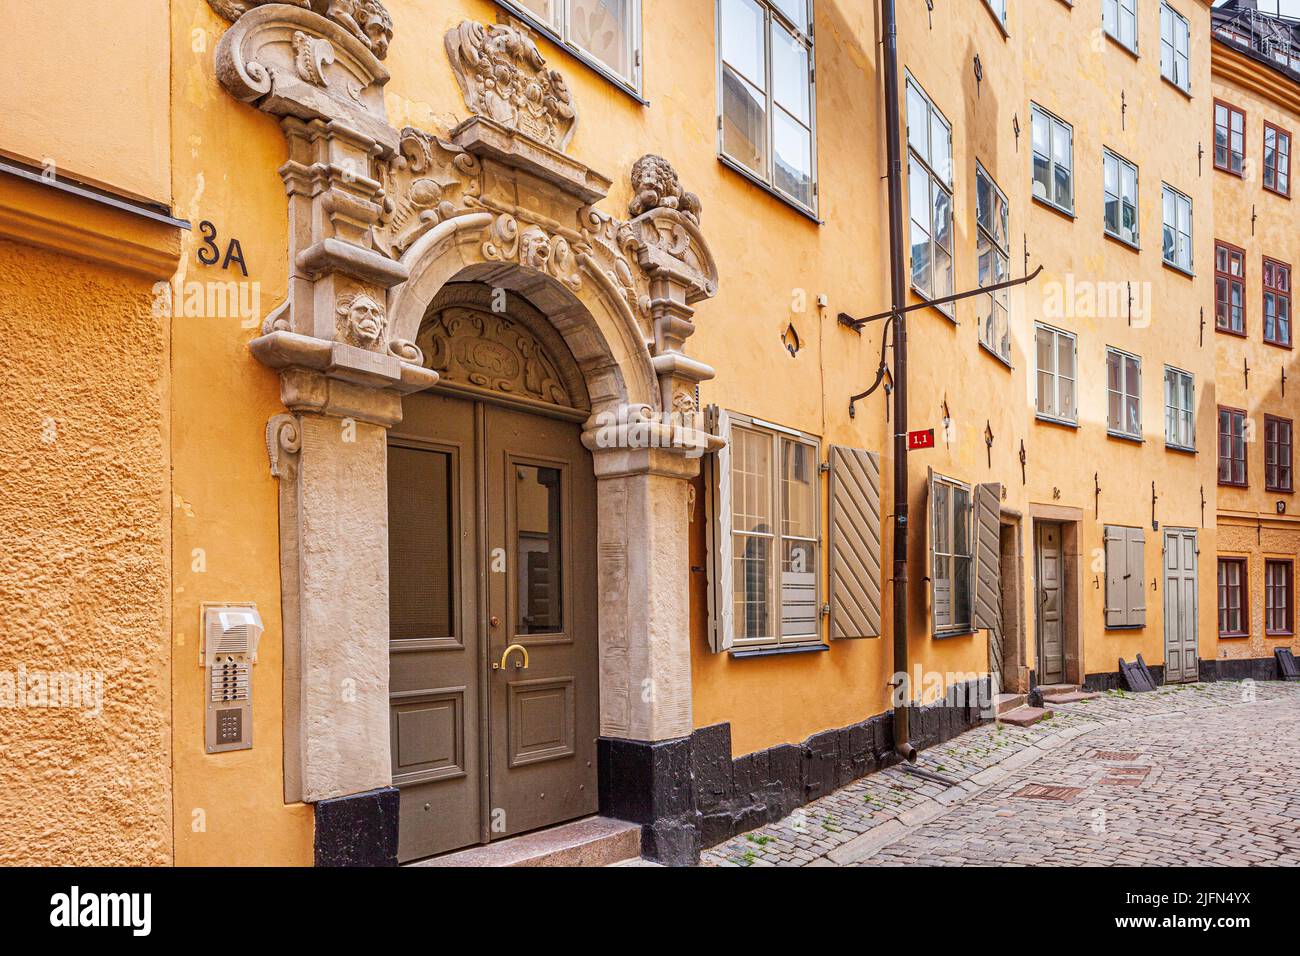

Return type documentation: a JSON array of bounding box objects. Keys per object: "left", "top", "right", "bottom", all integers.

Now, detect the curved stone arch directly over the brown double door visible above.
[{"left": 389, "top": 213, "right": 660, "bottom": 415}]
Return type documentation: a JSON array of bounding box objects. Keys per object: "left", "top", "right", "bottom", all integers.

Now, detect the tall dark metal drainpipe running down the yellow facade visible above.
[{"left": 880, "top": 0, "right": 917, "bottom": 763}]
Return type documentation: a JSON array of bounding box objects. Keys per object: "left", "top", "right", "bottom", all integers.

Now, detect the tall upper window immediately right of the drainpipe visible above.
[{"left": 907, "top": 77, "right": 953, "bottom": 316}]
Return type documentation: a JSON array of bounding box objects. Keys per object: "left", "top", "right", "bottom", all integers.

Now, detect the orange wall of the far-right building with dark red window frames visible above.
[{"left": 1204, "top": 43, "right": 1300, "bottom": 659}]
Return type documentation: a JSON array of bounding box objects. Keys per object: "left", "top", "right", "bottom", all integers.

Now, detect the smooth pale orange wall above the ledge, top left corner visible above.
[{"left": 0, "top": 0, "right": 172, "bottom": 204}]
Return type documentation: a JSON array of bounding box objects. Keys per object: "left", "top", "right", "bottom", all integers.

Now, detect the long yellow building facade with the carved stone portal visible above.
[{"left": 0, "top": 0, "right": 1296, "bottom": 865}]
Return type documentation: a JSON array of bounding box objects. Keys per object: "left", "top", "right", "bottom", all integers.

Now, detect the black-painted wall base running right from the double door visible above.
[{"left": 598, "top": 680, "right": 991, "bottom": 866}]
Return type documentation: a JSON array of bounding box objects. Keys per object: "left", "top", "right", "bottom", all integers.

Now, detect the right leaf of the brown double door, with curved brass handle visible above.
[{"left": 485, "top": 406, "right": 598, "bottom": 839}]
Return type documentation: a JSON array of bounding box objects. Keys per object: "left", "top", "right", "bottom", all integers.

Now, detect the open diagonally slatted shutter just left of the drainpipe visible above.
[{"left": 829, "top": 445, "right": 881, "bottom": 640}]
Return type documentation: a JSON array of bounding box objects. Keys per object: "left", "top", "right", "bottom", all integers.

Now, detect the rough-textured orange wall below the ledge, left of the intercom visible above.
[{"left": 0, "top": 234, "right": 172, "bottom": 866}]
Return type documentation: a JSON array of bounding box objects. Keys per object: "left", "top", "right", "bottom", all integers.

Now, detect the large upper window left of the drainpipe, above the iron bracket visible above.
[{"left": 718, "top": 0, "right": 816, "bottom": 211}]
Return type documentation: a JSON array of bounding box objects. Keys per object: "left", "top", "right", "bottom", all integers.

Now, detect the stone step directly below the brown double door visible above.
[{"left": 411, "top": 817, "right": 641, "bottom": 866}]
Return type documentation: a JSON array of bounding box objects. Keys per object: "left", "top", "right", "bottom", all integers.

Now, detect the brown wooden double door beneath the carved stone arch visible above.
[{"left": 389, "top": 394, "right": 598, "bottom": 862}]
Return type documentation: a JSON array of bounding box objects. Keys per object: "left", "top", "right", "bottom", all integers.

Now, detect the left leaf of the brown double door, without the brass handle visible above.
[{"left": 389, "top": 395, "right": 484, "bottom": 861}]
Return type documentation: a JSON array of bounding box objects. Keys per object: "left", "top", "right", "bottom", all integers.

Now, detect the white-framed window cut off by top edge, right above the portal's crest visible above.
[{"left": 501, "top": 0, "right": 641, "bottom": 91}]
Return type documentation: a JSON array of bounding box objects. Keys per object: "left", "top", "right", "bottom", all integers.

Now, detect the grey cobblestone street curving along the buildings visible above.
[{"left": 702, "top": 682, "right": 1300, "bottom": 866}]
